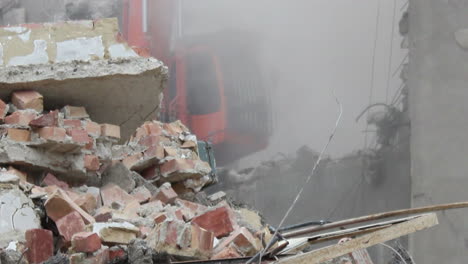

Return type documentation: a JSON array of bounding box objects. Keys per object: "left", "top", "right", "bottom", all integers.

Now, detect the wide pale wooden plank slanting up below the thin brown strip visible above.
[{"left": 276, "top": 213, "right": 438, "bottom": 264}]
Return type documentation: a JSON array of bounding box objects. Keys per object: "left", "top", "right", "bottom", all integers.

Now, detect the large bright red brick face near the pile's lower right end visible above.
[{"left": 192, "top": 206, "right": 235, "bottom": 238}]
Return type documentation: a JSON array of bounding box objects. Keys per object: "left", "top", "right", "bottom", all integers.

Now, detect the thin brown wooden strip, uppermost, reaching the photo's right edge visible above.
[{"left": 282, "top": 202, "right": 468, "bottom": 238}]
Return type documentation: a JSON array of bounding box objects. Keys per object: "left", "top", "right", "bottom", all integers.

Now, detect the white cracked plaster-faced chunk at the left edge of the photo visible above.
[{"left": 0, "top": 187, "right": 41, "bottom": 235}]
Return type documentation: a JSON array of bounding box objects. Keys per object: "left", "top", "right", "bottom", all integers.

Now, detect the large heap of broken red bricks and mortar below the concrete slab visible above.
[{"left": 0, "top": 90, "right": 269, "bottom": 263}]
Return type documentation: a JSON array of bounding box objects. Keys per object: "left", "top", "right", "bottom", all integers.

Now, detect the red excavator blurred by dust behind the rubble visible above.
[{"left": 121, "top": 0, "right": 272, "bottom": 165}]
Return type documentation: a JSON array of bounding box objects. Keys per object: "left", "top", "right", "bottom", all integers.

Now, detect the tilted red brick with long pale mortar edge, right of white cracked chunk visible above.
[{"left": 44, "top": 189, "right": 95, "bottom": 224}]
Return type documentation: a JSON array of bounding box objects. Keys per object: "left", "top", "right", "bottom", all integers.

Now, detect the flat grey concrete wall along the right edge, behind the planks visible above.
[{"left": 408, "top": 0, "right": 468, "bottom": 263}]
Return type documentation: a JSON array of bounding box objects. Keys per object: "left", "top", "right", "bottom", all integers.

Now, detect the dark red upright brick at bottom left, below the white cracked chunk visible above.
[{"left": 25, "top": 229, "right": 54, "bottom": 264}]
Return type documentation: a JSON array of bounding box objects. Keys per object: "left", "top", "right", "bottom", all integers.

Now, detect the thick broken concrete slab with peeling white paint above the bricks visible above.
[{"left": 0, "top": 19, "right": 168, "bottom": 140}]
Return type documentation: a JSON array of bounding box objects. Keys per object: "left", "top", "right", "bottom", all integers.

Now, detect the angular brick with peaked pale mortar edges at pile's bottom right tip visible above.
[{"left": 215, "top": 227, "right": 260, "bottom": 256}]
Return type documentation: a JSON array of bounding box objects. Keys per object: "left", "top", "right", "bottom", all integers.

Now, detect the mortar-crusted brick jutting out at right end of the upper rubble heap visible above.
[{"left": 160, "top": 158, "right": 211, "bottom": 182}]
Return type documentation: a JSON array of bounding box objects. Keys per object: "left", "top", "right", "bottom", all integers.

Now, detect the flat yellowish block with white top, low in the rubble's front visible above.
[{"left": 93, "top": 222, "right": 140, "bottom": 245}]
